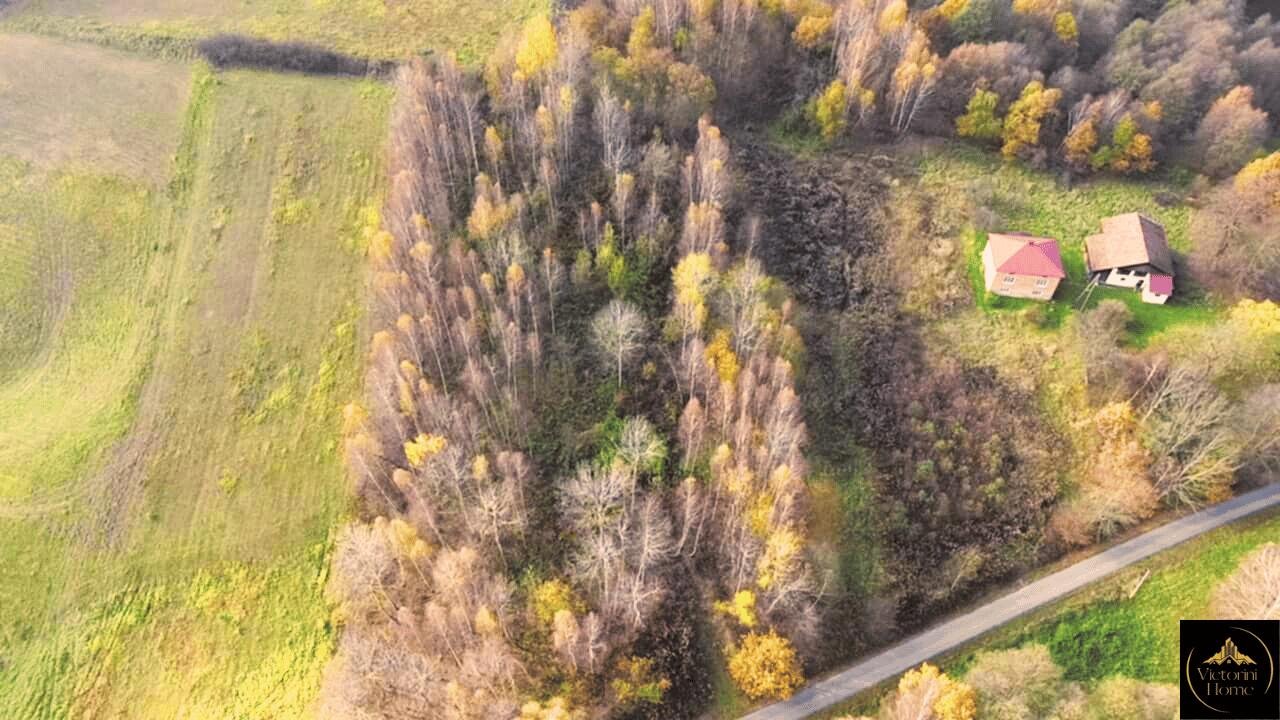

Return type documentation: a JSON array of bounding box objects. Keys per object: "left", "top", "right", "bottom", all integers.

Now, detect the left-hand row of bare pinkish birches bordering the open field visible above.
[{"left": 324, "top": 49, "right": 563, "bottom": 719}]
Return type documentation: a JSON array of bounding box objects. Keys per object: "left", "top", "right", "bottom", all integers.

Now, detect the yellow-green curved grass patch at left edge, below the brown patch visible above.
[{"left": 0, "top": 159, "right": 165, "bottom": 502}]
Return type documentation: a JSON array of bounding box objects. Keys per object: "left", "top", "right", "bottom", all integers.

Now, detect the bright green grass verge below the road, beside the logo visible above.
[{"left": 815, "top": 511, "right": 1280, "bottom": 719}]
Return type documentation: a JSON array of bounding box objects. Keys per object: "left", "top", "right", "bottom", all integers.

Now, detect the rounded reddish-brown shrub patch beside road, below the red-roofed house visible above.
[{"left": 883, "top": 363, "right": 1059, "bottom": 621}]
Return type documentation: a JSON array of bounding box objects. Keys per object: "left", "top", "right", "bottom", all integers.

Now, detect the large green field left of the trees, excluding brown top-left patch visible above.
[{"left": 0, "top": 44, "right": 390, "bottom": 719}]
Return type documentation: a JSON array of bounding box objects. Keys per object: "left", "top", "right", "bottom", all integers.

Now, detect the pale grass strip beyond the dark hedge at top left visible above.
[{"left": 5, "top": 0, "right": 550, "bottom": 60}]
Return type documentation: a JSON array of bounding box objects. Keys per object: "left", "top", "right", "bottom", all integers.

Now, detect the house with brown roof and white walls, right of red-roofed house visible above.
[{"left": 1084, "top": 213, "right": 1174, "bottom": 305}]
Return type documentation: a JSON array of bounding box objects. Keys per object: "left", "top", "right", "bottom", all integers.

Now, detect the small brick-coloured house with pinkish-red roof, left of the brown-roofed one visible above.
[{"left": 982, "top": 232, "right": 1066, "bottom": 300}]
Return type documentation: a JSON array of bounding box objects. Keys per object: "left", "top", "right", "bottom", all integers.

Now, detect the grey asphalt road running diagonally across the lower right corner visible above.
[{"left": 742, "top": 483, "right": 1280, "bottom": 720}]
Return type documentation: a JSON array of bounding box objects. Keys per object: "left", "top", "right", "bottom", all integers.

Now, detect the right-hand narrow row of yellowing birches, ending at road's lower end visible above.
[{"left": 667, "top": 122, "right": 820, "bottom": 697}]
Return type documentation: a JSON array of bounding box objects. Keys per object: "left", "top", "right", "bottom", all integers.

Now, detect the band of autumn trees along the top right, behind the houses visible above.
[{"left": 777, "top": 0, "right": 1280, "bottom": 177}]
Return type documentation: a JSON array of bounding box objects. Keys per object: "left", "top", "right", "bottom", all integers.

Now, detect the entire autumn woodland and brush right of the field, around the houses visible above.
[{"left": 323, "top": 0, "right": 1280, "bottom": 720}]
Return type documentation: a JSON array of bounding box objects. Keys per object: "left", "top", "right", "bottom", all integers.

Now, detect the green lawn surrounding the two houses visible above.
[{"left": 920, "top": 143, "right": 1219, "bottom": 346}]
